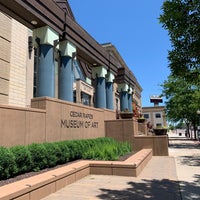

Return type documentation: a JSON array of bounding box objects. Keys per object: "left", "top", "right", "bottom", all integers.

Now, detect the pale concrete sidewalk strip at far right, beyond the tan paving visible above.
[{"left": 169, "top": 138, "right": 200, "bottom": 200}]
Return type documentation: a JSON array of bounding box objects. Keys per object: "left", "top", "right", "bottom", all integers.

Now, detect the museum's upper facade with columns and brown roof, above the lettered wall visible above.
[{"left": 0, "top": 0, "right": 142, "bottom": 111}]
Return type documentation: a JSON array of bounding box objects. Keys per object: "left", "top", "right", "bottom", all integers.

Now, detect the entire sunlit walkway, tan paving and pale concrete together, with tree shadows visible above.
[{"left": 43, "top": 138, "right": 200, "bottom": 200}]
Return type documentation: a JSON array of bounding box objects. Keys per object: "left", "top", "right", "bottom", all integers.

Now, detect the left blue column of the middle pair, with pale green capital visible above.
[{"left": 92, "top": 66, "right": 107, "bottom": 108}]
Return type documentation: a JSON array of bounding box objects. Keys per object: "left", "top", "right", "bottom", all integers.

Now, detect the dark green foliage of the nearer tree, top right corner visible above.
[{"left": 159, "top": 0, "right": 200, "bottom": 83}]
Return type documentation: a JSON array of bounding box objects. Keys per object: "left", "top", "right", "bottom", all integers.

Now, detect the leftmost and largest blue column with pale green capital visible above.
[{"left": 33, "top": 26, "right": 59, "bottom": 97}]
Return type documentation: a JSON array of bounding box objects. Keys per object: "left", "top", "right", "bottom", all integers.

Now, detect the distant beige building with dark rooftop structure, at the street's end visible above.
[{"left": 142, "top": 95, "right": 167, "bottom": 127}]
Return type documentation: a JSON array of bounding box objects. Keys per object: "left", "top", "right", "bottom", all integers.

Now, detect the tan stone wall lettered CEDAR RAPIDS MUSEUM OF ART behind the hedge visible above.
[{"left": 0, "top": 97, "right": 116, "bottom": 146}]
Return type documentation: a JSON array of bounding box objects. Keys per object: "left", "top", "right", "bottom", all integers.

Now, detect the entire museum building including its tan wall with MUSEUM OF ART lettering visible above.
[{"left": 0, "top": 0, "right": 142, "bottom": 146}]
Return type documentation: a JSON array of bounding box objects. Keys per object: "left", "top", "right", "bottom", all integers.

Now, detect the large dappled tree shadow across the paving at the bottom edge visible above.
[{"left": 97, "top": 178, "right": 200, "bottom": 200}]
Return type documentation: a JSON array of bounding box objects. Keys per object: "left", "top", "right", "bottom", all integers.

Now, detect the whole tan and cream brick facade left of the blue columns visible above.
[{"left": 0, "top": 12, "right": 34, "bottom": 107}]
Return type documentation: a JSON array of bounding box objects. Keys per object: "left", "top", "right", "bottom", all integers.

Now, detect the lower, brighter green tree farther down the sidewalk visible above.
[{"left": 162, "top": 75, "right": 200, "bottom": 138}]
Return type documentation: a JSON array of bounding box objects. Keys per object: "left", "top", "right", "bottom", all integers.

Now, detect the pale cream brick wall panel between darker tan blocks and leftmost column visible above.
[{"left": 9, "top": 19, "right": 33, "bottom": 106}]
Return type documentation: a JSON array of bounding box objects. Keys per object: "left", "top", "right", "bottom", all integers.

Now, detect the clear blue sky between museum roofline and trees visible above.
[{"left": 68, "top": 0, "right": 170, "bottom": 107}]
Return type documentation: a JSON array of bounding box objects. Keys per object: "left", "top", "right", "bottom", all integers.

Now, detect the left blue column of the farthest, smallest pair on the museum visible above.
[{"left": 118, "top": 83, "right": 130, "bottom": 111}]
